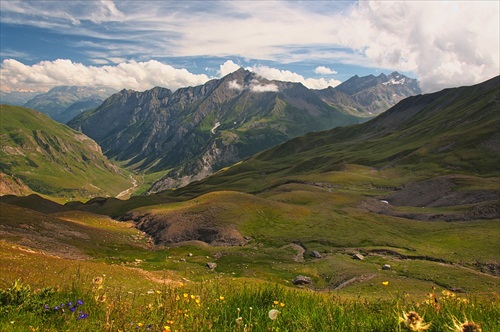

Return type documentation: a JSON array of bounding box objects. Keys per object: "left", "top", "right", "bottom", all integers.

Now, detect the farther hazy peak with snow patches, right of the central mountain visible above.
[{"left": 318, "top": 72, "right": 422, "bottom": 117}]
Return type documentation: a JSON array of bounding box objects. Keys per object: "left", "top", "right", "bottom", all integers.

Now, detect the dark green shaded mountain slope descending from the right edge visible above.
[{"left": 175, "top": 77, "right": 500, "bottom": 210}]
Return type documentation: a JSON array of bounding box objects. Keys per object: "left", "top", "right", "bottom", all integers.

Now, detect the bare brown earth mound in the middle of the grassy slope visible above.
[{"left": 121, "top": 208, "right": 248, "bottom": 246}]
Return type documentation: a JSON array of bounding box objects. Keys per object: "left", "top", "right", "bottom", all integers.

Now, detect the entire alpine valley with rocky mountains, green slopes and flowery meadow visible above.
[{"left": 0, "top": 69, "right": 500, "bottom": 332}]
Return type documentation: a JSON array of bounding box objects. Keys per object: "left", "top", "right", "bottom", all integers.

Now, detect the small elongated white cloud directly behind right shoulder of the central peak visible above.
[{"left": 247, "top": 66, "right": 342, "bottom": 89}]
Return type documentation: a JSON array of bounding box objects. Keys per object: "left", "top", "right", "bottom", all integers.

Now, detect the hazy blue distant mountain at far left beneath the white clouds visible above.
[{"left": 23, "top": 86, "right": 116, "bottom": 123}]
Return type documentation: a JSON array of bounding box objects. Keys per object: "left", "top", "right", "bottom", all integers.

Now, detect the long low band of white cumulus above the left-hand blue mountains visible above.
[{"left": 0, "top": 59, "right": 209, "bottom": 91}]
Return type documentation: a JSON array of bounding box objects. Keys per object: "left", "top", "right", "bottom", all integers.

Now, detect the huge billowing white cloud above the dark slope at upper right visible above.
[{"left": 336, "top": 1, "right": 500, "bottom": 92}]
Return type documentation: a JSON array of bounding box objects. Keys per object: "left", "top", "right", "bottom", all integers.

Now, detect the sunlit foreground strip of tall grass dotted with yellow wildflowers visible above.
[{"left": 0, "top": 276, "right": 500, "bottom": 332}]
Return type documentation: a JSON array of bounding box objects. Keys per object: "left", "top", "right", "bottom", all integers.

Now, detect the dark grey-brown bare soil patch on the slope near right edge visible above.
[{"left": 361, "top": 176, "right": 500, "bottom": 221}]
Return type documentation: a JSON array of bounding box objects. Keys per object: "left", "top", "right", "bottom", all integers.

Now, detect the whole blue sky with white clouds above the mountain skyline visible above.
[{"left": 0, "top": 0, "right": 500, "bottom": 92}]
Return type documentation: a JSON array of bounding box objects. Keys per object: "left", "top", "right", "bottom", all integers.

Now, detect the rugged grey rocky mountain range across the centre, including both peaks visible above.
[{"left": 68, "top": 68, "right": 420, "bottom": 193}]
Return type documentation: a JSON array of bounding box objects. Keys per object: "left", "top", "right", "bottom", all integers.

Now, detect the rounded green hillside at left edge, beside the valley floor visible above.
[{"left": 0, "top": 105, "right": 131, "bottom": 200}]
